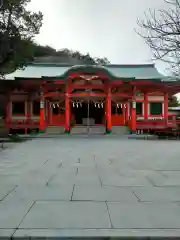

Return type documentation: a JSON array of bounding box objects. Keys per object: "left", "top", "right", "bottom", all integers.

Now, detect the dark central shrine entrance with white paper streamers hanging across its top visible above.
[{"left": 72, "top": 100, "right": 105, "bottom": 127}]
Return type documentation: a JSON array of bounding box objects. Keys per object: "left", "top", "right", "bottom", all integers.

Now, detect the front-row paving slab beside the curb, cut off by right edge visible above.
[{"left": 108, "top": 203, "right": 180, "bottom": 229}]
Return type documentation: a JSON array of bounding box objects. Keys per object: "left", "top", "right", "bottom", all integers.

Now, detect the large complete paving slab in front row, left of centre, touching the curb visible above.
[{"left": 19, "top": 202, "right": 110, "bottom": 229}]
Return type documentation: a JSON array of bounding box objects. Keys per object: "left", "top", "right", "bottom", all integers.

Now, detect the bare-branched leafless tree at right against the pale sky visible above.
[{"left": 138, "top": 0, "right": 180, "bottom": 76}]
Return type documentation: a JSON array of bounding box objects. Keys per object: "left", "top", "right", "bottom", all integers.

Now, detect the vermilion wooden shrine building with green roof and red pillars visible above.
[{"left": 0, "top": 63, "right": 180, "bottom": 133}]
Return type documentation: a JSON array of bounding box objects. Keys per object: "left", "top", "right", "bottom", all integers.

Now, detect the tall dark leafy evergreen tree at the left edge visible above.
[{"left": 0, "top": 0, "right": 43, "bottom": 75}]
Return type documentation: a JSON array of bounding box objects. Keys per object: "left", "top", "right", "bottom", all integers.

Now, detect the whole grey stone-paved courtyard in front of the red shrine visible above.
[{"left": 0, "top": 136, "right": 180, "bottom": 239}]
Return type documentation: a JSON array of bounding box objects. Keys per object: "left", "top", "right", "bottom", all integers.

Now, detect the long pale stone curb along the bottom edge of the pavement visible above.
[{"left": 6, "top": 229, "right": 180, "bottom": 240}]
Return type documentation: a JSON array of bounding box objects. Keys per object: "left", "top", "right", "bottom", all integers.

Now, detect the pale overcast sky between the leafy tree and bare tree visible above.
[{"left": 29, "top": 0, "right": 165, "bottom": 72}]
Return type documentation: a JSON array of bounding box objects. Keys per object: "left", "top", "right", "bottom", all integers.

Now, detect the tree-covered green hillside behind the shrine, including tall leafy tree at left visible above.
[{"left": 0, "top": 0, "right": 109, "bottom": 76}]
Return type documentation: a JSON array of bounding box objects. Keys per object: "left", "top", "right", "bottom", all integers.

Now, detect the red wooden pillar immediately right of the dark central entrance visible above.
[{"left": 106, "top": 87, "right": 112, "bottom": 133}]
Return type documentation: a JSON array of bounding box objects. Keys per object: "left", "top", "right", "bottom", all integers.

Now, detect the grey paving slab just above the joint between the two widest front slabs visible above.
[{"left": 72, "top": 186, "right": 138, "bottom": 202}]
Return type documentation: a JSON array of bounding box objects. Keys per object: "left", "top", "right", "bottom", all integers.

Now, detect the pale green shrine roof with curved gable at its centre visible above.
[{"left": 5, "top": 63, "right": 164, "bottom": 80}]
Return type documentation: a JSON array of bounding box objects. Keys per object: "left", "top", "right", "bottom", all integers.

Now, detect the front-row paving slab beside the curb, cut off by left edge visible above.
[{"left": 0, "top": 201, "right": 33, "bottom": 229}]
